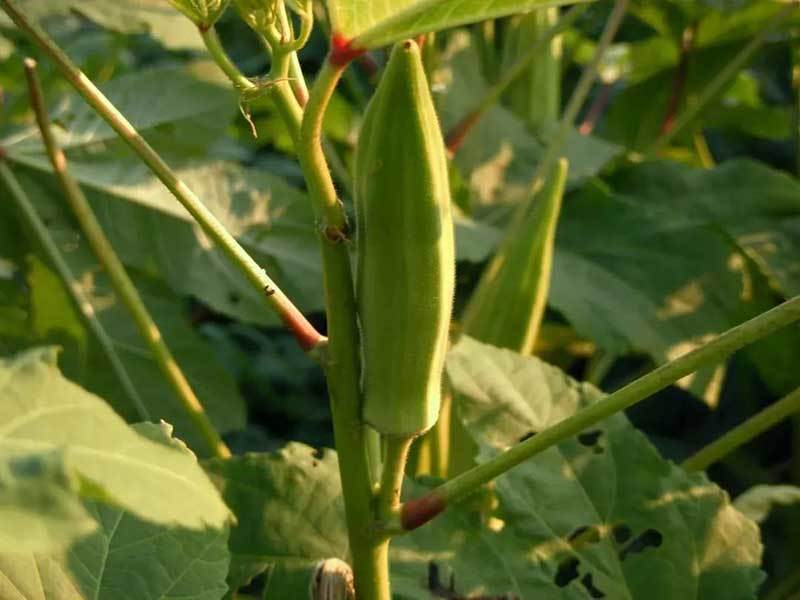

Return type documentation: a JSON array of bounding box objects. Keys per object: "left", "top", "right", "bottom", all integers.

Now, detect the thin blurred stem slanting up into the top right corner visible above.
[{"left": 648, "top": 2, "right": 797, "bottom": 153}]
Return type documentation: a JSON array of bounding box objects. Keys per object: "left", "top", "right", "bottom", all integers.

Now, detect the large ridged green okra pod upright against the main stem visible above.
[{"left": 355, "top": 40, "right": 455, "bottom": 436}]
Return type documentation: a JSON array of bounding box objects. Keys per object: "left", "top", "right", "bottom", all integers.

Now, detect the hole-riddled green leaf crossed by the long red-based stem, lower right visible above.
[{"left": 392, "top": 338, "right": 763, "bottom": 600}]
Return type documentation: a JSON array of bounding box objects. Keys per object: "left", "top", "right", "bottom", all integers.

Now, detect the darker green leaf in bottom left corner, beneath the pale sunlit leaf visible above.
[{"left": 0, "top": 502, "right": 229, "bottom": 600}]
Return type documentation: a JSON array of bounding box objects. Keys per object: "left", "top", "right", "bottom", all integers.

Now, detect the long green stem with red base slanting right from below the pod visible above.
[{"left": 400, "top": 296, "right": 800, "bottom": 530}]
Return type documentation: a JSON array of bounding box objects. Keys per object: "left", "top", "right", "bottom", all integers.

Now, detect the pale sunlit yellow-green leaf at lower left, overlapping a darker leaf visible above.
[{"left": 0, "top": 348, "right": 230, "bottom": 528}]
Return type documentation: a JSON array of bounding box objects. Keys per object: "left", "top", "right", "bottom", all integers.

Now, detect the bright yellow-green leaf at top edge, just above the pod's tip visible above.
[{"left": 328, "top": 0, "right": 592, "bottom": 48}]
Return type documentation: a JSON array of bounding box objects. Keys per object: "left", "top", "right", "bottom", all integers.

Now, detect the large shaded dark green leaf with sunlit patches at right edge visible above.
[{"left": 550, "top": 161, "right": 800, "bottom": 398}]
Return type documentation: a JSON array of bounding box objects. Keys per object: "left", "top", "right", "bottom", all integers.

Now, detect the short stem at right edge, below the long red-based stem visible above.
[{"left": 681, "top": 388, "right": 800, "bottom": 471}]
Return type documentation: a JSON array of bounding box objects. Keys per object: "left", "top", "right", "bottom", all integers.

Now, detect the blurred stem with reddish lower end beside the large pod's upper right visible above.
[{"left": 447, "top": 4, "right": 589, "bottom": 152}]
